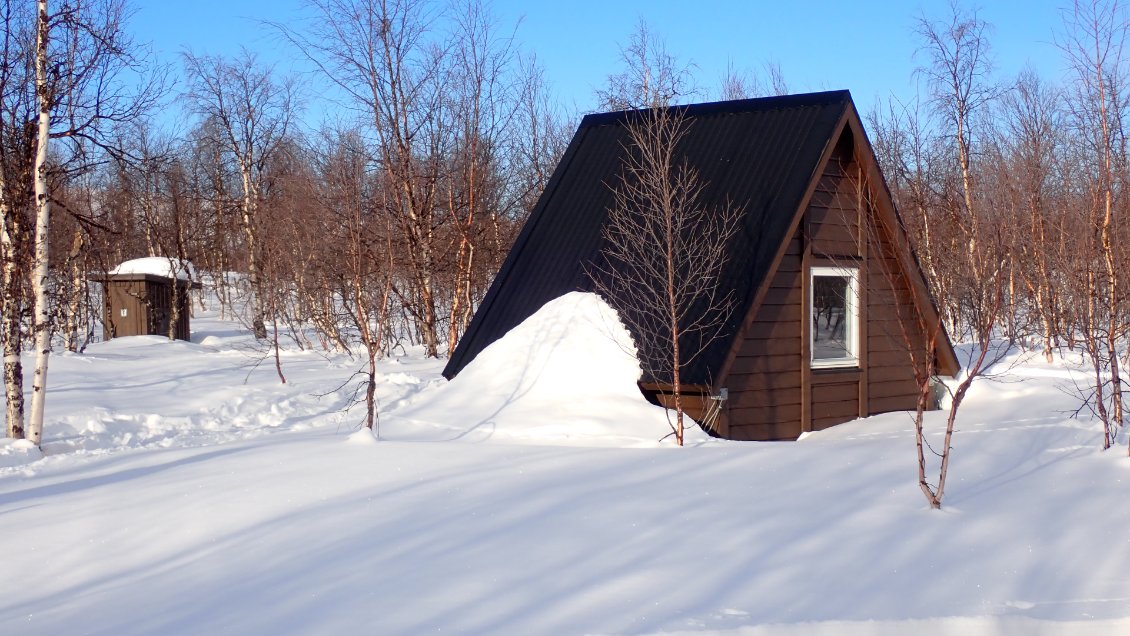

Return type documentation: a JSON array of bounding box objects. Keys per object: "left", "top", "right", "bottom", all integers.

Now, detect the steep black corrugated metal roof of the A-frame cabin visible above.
[{"left": 443, "top": 90, "right": 851, "bottom": 384}]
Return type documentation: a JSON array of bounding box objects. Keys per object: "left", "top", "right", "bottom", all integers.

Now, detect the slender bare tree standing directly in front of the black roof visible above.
[{"left": 589, "top": 108, "right": 741, "bottom": 445}]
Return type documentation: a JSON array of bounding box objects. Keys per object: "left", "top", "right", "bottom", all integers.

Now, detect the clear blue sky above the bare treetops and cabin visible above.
[{"left": 131, "top": 0, "right": 1063, "bottom": 121}]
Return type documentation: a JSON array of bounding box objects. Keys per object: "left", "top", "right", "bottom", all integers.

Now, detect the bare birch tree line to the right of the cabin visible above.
[{"left": 868, "top": 0, "right": 1130, "bottom": 458}]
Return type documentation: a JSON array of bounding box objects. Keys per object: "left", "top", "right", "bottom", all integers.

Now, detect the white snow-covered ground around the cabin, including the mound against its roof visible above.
[{"left": 0, "top": 295, "right": 1130, "bottom": 636}]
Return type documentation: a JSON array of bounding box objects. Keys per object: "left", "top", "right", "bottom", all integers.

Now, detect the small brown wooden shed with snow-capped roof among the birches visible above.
[{"left": 95, "top": 258, "right": 200, "bottom": 340}]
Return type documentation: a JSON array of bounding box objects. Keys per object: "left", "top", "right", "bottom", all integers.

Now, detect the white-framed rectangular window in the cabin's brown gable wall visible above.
[{"left": 808, "top": 268, "right": 859, "bottom": 368}]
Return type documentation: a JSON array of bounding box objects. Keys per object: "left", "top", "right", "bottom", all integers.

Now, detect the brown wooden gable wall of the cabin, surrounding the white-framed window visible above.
[{"left": 719, "top": 128, "right": 924, "bottom": 441}]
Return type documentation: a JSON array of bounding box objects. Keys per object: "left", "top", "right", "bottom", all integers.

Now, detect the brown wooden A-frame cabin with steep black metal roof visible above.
[{"left": 444, "top": 90, "right": 958, "bottom": 439}]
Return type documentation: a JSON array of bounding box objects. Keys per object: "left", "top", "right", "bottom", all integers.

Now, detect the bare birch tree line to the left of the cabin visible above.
[{"left": 0, "top": 0, "right": 567, "bottom": 443}]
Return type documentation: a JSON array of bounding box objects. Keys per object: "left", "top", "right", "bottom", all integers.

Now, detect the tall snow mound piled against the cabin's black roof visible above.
[{"left": 390, "top": 291, "right": 709, "bottom": 446}]
